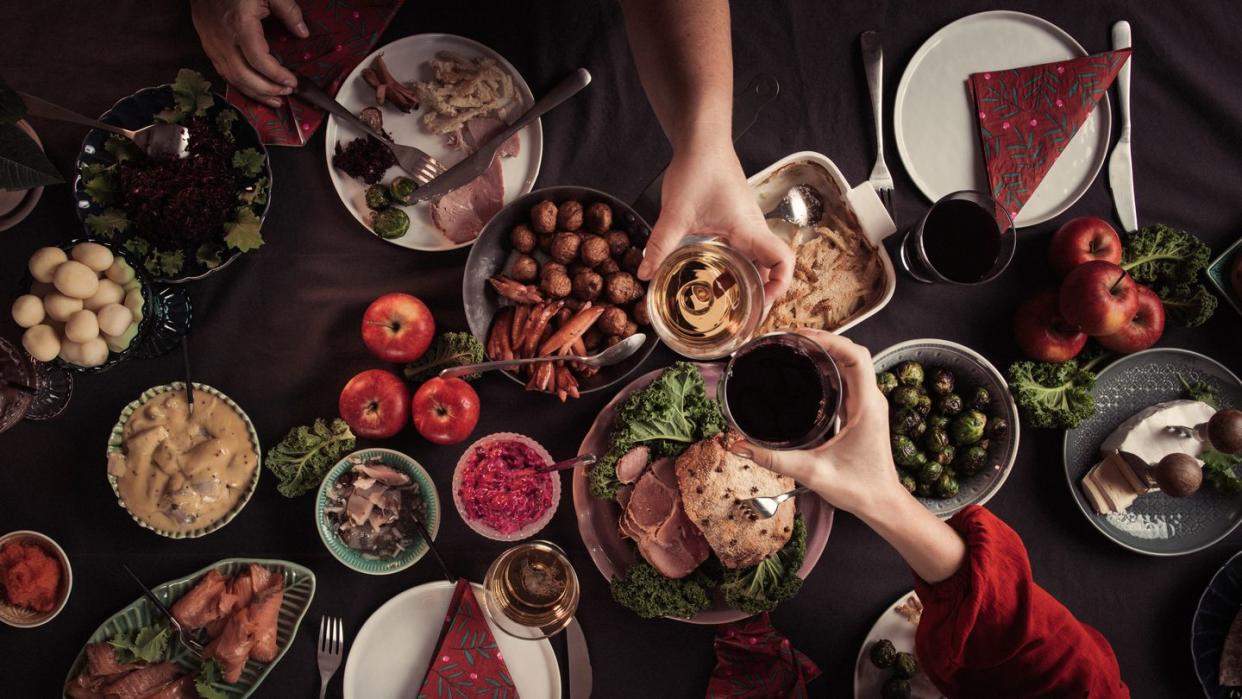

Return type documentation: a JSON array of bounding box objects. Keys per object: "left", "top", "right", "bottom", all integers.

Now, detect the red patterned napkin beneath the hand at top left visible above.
[{"left": 225, "top": 0, "right": 404, "bottom": 145}]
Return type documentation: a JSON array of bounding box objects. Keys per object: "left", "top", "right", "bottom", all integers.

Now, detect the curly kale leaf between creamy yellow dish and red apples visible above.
[{"left": 265, "top": 418, "right": 356, "bottom": 498}]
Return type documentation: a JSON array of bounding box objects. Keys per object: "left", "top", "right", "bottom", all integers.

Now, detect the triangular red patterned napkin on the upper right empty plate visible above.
[{"left": 969, "top": 48, "right": 1130, "bottom": 219}]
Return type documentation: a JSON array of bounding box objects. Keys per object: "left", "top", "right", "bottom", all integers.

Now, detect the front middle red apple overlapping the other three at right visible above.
[{"left": 1057, "top": 259, "right": 1139, "bottom": 335}]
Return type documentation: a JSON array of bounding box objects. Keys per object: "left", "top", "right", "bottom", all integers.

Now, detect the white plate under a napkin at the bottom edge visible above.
[{"left": 344, "top": 580, "right": 560, "bottom": 699}]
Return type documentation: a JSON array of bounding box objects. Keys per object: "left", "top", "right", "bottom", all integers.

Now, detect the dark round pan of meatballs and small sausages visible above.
[{"left": 462, "top": 186, "right": 658, "bottom": 401}]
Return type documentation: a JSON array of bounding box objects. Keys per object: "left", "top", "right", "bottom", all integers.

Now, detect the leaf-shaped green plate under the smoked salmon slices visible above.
[{"left": 65, "top": 559, "right": 315, "bottom": 698}]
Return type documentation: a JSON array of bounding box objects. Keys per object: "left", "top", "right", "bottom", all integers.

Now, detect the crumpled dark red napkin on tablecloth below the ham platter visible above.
[{"left": 707, "top": 612, "right": 820, "bottom": 699}]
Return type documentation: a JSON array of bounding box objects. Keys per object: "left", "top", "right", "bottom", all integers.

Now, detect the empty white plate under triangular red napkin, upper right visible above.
[{"left": 893, "top": 10, "right": 1112, "bottom": 227}]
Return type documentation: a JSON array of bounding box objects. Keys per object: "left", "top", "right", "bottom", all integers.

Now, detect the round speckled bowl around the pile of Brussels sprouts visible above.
[{"left": 874, "top": 339, "right": 1021, "bottom": 518}]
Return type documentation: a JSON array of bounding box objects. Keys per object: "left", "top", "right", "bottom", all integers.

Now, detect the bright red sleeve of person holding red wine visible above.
[{"left": 914, "top": 507, "right": 1130, "bottom": 698}]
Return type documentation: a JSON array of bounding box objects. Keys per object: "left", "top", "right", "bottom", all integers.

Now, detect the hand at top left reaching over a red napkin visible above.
[{"left": 190, "top": 0, "right": 311, "bottom": 107}]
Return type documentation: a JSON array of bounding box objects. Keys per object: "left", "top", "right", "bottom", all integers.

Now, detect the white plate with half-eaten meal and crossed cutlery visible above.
[{"left": 324, "top": 34, "right": 543, "bottom": 252}]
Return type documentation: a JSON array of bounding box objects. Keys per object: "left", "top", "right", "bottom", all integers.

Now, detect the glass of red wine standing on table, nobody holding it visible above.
[{"left": 902, "top": 190, "right": 1017, "bottom": 286}]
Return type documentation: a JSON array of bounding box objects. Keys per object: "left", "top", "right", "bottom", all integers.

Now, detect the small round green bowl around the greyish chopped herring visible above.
[{"left": 314, "top": 449, "right": 440, "bottom": 575}]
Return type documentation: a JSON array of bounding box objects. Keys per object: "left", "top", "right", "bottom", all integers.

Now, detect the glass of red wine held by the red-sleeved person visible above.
[{"left": 717, "top": 333, "right": 841, "bottom": 449}]
